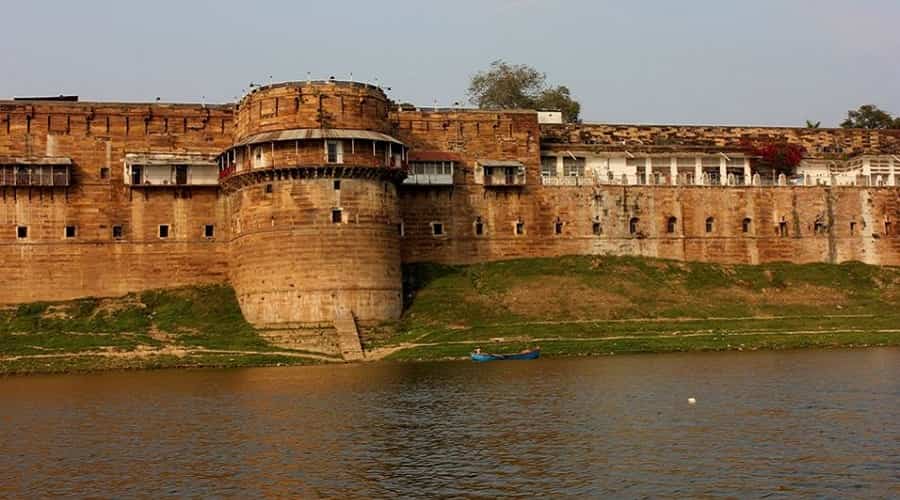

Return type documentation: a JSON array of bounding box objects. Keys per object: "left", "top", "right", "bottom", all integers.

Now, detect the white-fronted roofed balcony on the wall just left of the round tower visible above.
[{"left": 125, "top": 153, "right": 219, "bottom": 188}]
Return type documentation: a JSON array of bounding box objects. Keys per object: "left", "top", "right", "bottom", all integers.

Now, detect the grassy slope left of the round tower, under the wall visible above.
[{"left": 0, "top": 286, "right": 338, "bottom": 374}]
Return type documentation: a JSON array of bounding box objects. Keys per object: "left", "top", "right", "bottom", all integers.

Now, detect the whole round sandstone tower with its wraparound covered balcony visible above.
[{"left": 220, "top": 81, "right": 406, "bottom": 326}]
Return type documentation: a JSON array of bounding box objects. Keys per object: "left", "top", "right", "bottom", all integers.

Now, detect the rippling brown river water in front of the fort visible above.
[{"left": 0, "top": 349, "right": 900, "bottom": 498}]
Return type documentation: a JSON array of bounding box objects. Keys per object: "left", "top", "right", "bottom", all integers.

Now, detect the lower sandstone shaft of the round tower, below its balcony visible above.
[{"left": 229, "top": 178, "right": 402, "bottom": 326}]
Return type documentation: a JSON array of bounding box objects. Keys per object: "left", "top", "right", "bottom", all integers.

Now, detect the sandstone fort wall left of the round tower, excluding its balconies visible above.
[{"left": 0, "top": 101, "right": 232, "bottom": 303}]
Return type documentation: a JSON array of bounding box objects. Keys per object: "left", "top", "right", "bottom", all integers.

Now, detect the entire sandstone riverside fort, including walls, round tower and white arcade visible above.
[{"left": 0, "top": 81, "right": 900, "bottom": 340}]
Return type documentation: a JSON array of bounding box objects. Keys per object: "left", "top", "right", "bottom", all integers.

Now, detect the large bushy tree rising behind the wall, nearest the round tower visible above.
[{"left": 468, "top": 60, "right": 581, "bottom": 122}]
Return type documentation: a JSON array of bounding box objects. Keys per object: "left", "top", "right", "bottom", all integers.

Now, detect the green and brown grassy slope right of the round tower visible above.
[{"left": 370, "top": 257, "right": 900, "bottom": 360}]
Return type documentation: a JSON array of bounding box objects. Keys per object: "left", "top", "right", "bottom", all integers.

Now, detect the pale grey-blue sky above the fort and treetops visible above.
[{"left": 0, "top": 0, "right": 900, "bottom": 126}]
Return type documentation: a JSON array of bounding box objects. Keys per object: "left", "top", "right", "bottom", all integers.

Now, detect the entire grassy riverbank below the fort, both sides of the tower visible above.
[{"left": 0, "top": 257, "right": 900, "bottom": 374}]
